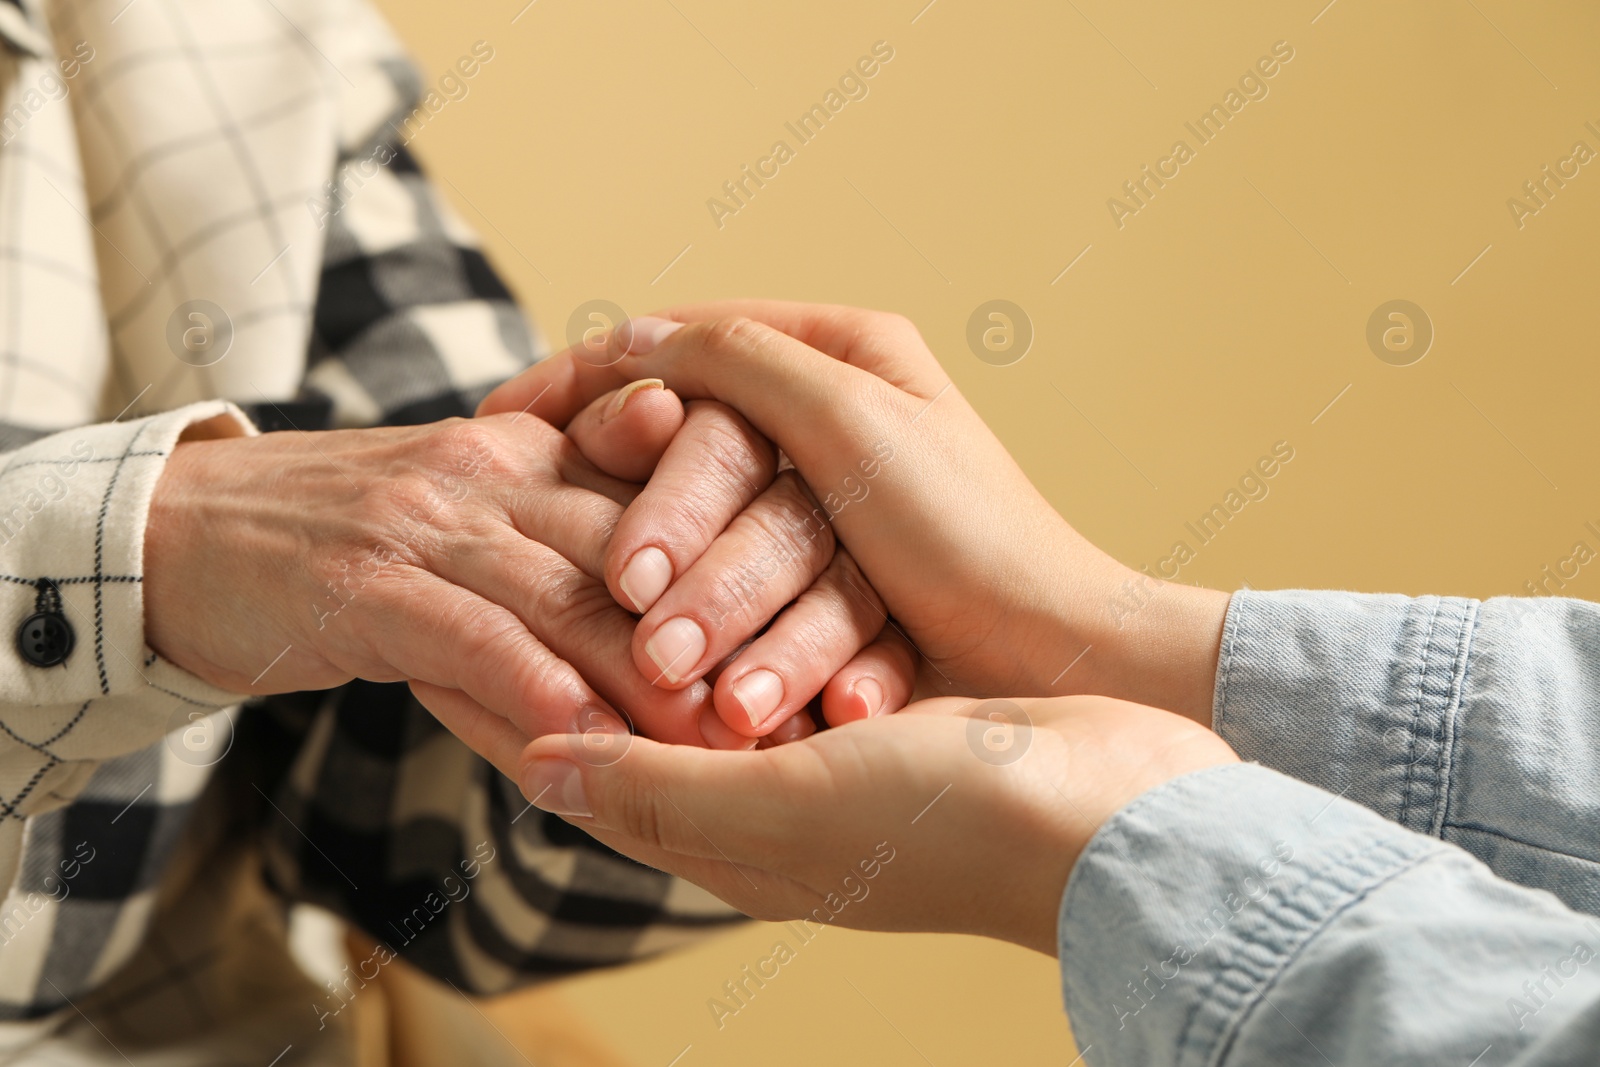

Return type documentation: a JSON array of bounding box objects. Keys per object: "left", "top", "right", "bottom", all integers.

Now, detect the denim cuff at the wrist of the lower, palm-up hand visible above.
[{"left": 1058, "top": 763, "right": 1448, "bottom": 1065}]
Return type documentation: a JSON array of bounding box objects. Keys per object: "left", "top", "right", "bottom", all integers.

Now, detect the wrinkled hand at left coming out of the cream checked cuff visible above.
[{"left": 144, "top": 400, "right": 709, "bottom": 744}]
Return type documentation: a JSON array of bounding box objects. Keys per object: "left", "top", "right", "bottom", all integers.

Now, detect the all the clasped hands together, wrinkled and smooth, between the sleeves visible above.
[{"left": 146, "top": 301, "right": 1235, "bottom": 955}]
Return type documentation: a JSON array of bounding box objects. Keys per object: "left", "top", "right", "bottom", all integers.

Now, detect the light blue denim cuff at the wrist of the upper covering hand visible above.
[{"left": 1211, "top": 590, "right": 1478, "bottom": 837}]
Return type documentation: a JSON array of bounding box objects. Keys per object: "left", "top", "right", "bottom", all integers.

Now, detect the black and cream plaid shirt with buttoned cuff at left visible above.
[{"left": 0, "top": 0, "right": 733, "bottom": 1056}]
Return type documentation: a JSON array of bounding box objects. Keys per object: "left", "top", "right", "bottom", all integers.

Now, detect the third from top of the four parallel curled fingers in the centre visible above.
[{"left": 712, "top": 549, "right": 888, "bottom": 737}]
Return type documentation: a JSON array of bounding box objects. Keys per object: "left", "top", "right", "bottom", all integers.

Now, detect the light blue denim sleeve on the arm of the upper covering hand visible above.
[{"left": 1213, "top": 592, "right": 1600, "bottom": 913}]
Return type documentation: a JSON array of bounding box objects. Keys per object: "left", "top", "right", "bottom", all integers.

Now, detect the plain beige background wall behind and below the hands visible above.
[{"left": 371, "top": 0, "right": 1600, "bottom": 1067}]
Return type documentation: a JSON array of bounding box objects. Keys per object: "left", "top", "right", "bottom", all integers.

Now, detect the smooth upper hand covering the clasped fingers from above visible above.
[{"left": 480, "top": 301, "right": 1227, "bottom": 731}]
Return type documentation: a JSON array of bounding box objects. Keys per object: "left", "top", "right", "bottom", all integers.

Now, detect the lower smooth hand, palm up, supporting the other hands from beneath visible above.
[{"left": 518, "top": 697, "right": 1237, "bottom": 955}]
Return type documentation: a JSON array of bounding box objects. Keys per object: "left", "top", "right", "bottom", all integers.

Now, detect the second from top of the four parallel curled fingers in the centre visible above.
[{"left": 634, "top": 470, "right": 834, "bottom": 687}]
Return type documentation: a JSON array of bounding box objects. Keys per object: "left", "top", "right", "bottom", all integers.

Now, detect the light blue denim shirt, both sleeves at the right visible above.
[{"left": 1059, "top": 592, "right": 1600, "bottom": 1067}]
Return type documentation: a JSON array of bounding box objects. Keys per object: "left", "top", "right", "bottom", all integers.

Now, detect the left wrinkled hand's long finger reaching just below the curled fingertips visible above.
[{"left": 435, "top": 530, "right": 710, "bottom": 745}]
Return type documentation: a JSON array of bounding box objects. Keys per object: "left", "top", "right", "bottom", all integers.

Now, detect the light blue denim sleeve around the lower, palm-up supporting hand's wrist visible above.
[{"left": 1059, "top": 763, "right": 1600, "bottom": 1067}]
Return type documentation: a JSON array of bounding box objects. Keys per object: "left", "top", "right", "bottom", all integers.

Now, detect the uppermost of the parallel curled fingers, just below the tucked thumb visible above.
[{"left": 606, "top": 400, "right": 778, "bottom": 613}]
